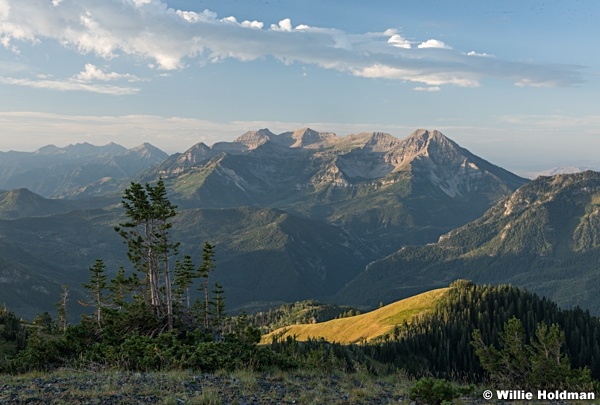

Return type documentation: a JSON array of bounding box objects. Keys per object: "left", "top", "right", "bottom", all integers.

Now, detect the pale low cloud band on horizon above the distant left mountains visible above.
[{"left": 0, "top": 111, "right": 290, "bottom": 153}]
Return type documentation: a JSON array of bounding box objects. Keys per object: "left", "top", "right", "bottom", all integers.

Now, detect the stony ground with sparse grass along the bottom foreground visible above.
[{"left": 0, "top": 370, "right": 422, "bottom": 405}]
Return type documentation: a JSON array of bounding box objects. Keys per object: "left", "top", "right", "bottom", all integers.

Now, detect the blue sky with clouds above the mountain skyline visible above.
[{"left": 0, "top": 0, "right": 600, "bottom": 171}]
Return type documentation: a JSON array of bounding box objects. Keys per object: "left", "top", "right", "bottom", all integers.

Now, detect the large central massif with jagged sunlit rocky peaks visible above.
[{"left": 148, "top": 128, "right": 526, "bottom": 255}]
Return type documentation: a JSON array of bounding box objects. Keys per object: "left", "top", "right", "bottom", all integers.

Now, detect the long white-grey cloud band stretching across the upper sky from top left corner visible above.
[{"left": 0, "top": 0, "right": 581, "bottom": 86}]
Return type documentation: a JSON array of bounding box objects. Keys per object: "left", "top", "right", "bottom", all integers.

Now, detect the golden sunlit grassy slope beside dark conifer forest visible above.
[{"left": 262, "top": 288, "right": 448, "bottom": 344}]
